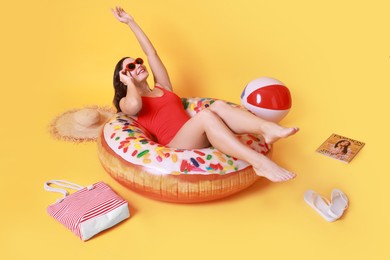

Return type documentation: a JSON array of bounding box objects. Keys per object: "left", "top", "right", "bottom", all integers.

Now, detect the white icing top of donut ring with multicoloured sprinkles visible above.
[{"left": 103, "top": 98, "right": 269, "bottom": 175}]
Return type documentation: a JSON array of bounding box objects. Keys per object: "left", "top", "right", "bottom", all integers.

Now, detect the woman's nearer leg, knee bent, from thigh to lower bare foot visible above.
[{"left": 168, "top": 109, "right": 295, "bottom": 182}]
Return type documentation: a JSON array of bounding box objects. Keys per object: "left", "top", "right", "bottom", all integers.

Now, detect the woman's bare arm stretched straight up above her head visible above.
[{"left": 111, "top": 7, "right": 172, "bottom": 91}]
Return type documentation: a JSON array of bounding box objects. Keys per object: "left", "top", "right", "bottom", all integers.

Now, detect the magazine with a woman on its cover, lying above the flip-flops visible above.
[{"left": 316, "top": 134, "right": 365, "bottom": 163}]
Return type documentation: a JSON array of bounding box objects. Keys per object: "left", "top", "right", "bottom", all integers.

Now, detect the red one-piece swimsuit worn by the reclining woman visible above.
[{"left": 137, "top": 86, "right": 190, "bottom": 145}]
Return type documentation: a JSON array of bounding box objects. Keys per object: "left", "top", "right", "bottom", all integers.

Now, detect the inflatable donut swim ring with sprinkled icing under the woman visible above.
[{"left": 97, "top": 98, "right": 270, "bottom": 203}]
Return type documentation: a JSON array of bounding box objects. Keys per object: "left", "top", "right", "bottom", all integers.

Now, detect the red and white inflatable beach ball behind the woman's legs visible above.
[{"left": 241, "top": 77, "right": 291, "bottom": 123}]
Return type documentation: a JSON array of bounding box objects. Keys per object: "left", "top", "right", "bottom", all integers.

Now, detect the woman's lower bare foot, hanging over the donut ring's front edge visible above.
[{"left": 253, "top": 158, "right": 296, "bottom": 182}]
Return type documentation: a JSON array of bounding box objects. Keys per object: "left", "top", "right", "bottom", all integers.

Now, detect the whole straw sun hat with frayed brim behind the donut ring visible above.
[{"left": 49, "top": 106, "right": 115, "bottom": 142}]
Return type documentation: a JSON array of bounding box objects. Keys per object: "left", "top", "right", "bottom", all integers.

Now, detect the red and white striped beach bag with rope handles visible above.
[{"left": 44, "top": 180, "right": 130, "bottom": 241}]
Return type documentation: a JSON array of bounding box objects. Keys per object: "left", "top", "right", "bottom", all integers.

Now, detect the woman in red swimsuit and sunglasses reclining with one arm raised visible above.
[{"left": 112, "top": 7, "right": 298, "bottom": 182}]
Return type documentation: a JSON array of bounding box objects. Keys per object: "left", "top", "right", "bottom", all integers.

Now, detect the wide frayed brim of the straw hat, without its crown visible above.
[{"left": 49, "top": 106, "right": 115, "bottom": 143}]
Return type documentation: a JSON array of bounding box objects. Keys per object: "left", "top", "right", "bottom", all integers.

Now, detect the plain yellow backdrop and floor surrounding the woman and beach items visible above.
[{"left": 0, "top": 0, "right": 390, "bottom": 260}]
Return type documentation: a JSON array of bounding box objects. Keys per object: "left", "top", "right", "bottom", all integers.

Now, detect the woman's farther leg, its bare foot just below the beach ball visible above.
[{"left": 209, "top": 100, "right": 299, "bottom": 144}]
